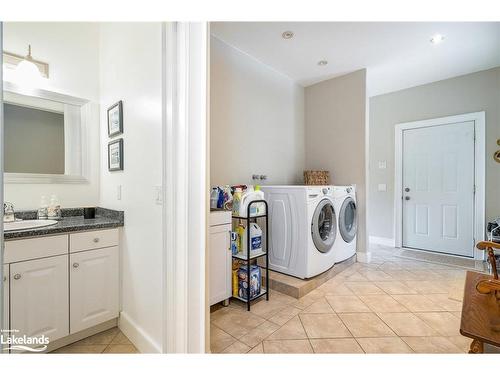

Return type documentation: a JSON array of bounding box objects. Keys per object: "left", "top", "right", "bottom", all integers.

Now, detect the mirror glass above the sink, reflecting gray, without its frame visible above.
[{"left": 4, "top": 104, "right": 64, "bottom": 174}]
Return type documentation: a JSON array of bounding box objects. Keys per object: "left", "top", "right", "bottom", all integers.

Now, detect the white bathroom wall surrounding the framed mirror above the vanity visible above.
[{"left": 3, "top": 22, "right": 99, "bottom": 210}]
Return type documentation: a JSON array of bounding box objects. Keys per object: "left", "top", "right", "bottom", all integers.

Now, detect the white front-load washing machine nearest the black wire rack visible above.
[{"left": 261, "top": 186, "right": 338, "bottom": 279}]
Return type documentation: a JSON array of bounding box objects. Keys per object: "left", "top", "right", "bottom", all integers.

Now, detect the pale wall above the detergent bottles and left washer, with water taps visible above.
[{"left": 210, "top": 37, "right": 304, "bottom": 186}]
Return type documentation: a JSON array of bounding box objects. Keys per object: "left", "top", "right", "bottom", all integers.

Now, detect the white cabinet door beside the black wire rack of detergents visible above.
[{"left": 209, "top": 224, "right": 232, "bottom": 305}]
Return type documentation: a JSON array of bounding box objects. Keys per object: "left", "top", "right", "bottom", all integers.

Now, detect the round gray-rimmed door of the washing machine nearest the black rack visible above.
[{"left": 311, "top": 199, "right": 337, "bottom": 253}]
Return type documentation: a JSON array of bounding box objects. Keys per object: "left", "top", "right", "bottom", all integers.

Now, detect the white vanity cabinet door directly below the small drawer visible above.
[{"left": 70, "top": 246, "right": 119, "bottom": 334}]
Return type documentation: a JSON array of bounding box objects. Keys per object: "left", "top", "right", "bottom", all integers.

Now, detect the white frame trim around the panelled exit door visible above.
[{"left": 394, "top": 111, "right": 486, "bottom": 260}]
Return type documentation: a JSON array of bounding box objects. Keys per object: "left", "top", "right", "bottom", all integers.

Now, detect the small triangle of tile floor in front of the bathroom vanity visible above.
[{"left": 51, "top": 327, "right": 138, "bottom": 354}]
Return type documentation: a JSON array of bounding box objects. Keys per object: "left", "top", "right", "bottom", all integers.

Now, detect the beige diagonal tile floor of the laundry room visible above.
[{"left": 210, "top": 246, "right": 471, "bottom": 353}]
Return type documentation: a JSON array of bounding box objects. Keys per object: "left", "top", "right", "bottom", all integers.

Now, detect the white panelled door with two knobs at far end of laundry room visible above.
[{"left": 402, "top": 121, "right": 474, "bottom": 257}]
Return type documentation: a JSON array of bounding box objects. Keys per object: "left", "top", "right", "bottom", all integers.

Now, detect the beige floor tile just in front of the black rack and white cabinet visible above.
[{"left": 211, "top": 308, "right": 265, "bottom": 339}]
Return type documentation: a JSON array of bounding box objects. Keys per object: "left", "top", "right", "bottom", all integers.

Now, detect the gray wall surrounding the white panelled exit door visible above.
[{"left": 368, "top": 67, "right": 500, "bottom": 238}]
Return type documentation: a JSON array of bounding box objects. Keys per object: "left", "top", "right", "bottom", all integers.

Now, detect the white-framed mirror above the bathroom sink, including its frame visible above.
[{"left": 3, "top": 82, "right": 90, "bottom": 184}]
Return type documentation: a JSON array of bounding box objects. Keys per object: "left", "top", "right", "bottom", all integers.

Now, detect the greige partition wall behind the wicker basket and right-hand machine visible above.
[{"left": 305, "top": 69, "right": 367, "bottom": 252}]
